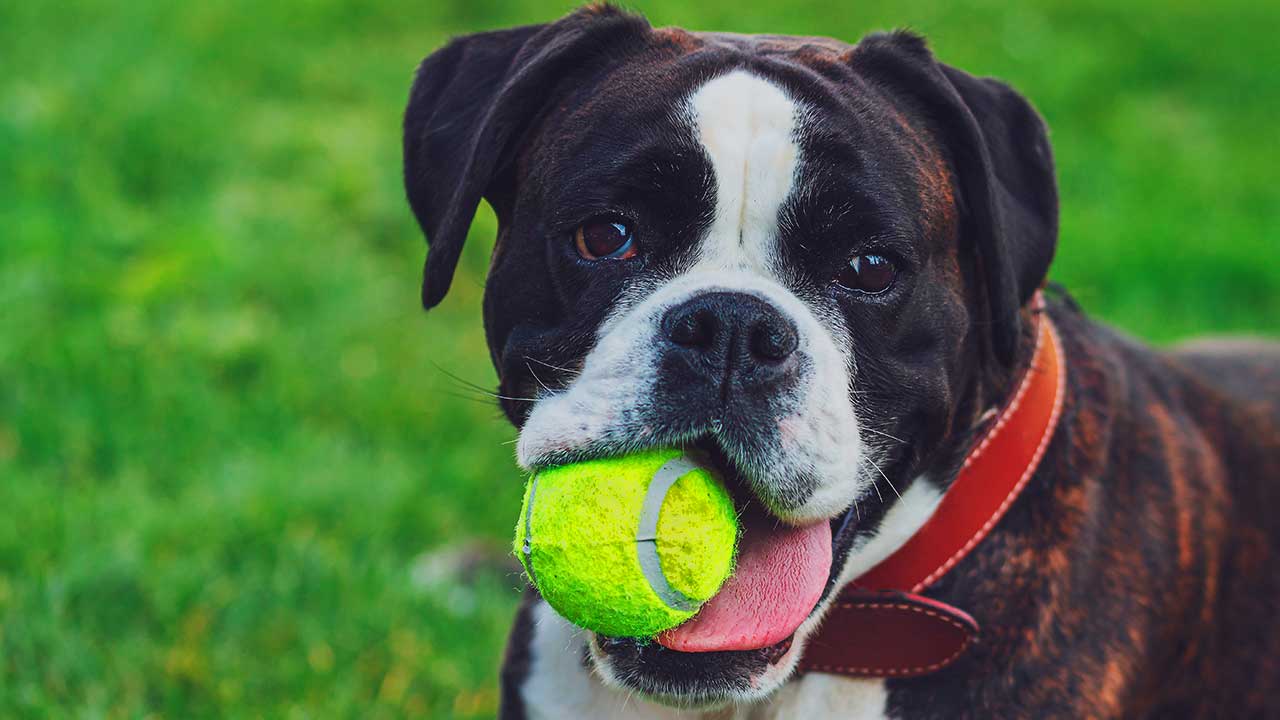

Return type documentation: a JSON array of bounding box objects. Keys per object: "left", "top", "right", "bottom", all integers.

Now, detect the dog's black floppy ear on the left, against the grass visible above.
[{"left": 404, "top": 5, "right": 649, "bottom": 309}]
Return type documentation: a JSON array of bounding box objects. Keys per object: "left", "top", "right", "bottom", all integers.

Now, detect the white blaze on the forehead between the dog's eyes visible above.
[{"left": 689, "top": 70, "right": 800, "bottom": 275}]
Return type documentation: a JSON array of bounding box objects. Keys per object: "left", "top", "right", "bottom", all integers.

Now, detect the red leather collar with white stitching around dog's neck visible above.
[{"left": 800, "top": 299, "right": 1066, "bottom": 678}]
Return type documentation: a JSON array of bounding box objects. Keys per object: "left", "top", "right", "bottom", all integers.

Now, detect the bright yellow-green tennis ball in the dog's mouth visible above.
[{"left": 515, "top": 450, "right": 737, "bottom": 638}]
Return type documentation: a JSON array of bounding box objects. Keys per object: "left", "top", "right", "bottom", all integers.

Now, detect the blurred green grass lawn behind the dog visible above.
[{"left": 0, "top": 0, "right": 1280, "bottom": 717}]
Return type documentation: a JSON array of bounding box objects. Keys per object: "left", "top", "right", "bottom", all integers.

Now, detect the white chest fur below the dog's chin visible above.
[{"left": 520, "top": 602, "right": 888, "bottom": 720}]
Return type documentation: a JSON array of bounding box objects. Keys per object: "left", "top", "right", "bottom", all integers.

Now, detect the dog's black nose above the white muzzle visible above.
[{"left": 662, "top": 292, "right": 800, "bottom": 383}]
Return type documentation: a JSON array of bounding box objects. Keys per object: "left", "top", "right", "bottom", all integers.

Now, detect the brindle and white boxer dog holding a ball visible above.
[{"left": 403, "top": 5, "right": 1280, "bottom": 720}]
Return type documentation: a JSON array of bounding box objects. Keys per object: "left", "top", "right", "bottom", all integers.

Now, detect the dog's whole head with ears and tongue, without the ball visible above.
[{"left": 406, "top": 9, "right": 1056, "bottom": 703}]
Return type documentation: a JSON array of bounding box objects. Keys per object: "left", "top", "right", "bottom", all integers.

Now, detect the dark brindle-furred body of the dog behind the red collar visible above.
[{"left": 888, "top": 302, "right": 1280, "bottom": 717}]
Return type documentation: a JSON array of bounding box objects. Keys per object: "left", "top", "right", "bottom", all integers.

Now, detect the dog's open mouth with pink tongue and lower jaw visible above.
[{"left": 593, "top": 438, "right": 849, "bottom": 703}]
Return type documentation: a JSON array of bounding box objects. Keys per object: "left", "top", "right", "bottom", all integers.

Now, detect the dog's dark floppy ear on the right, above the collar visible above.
[{"left": 852, "top": 32, "right": 1057, "bottom": 365}]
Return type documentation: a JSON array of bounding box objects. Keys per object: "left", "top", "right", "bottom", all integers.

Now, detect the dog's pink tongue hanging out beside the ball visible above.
[{"left": 658, "top": 509, "right": 831, "bottom": 652}]
